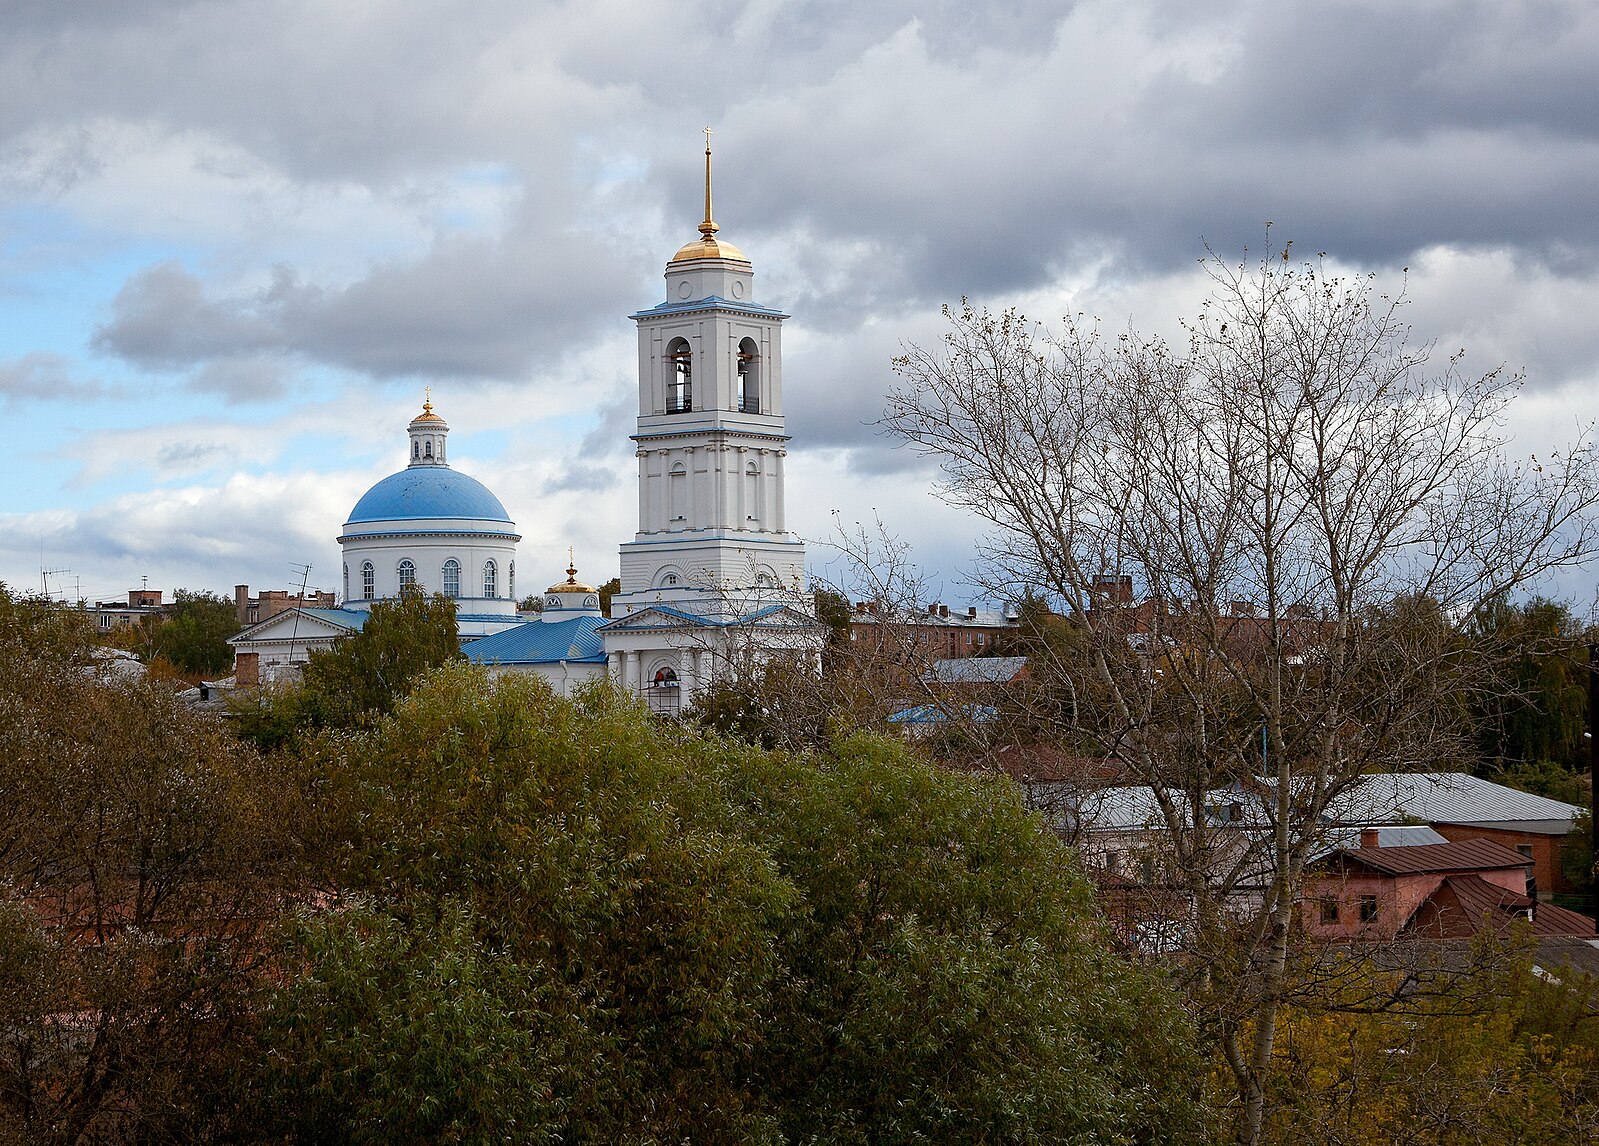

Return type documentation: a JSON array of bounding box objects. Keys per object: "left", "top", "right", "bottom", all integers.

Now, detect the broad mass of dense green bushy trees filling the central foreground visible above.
[{"left": 253, "top": 667, "right": 1206, "bottom": 1143}]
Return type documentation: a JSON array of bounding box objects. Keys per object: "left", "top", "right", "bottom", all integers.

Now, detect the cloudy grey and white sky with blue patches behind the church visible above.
[{"left": 0, "top": 0, "right": 1599, "bottom": 603}]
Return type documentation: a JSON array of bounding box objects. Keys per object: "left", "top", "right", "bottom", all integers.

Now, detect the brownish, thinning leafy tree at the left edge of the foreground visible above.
[{"left": 0, "top": 588, "right": 296, "bottom": 1143}]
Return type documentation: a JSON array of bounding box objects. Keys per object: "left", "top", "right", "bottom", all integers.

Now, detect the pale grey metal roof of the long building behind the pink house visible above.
[{"left": 1327, "top": 772, "right": 1581, "bottom": 834}]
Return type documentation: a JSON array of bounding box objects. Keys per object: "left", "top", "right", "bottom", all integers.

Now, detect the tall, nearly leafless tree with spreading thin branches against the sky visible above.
[{"left": 884, "top": 249, "right": 1599, "bottom": 1143}]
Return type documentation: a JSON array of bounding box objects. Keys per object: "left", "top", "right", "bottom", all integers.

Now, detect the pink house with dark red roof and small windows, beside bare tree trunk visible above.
[{"left": 1300, "top": 839, "right": 1594, "bottom": 941}]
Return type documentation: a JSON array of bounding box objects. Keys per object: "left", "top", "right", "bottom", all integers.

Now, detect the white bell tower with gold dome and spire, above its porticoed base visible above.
[{"left": 614, "top": 129, "right": 804, "bottom": 615}]
